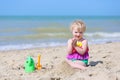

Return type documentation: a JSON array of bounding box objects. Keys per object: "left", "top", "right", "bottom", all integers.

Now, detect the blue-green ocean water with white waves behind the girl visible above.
[{"left": 0, "top": 16, "right": 120, "bottom": 50}]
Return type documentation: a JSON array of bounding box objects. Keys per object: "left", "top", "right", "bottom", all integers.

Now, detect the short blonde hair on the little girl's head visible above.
[{"left": 70, "top": 20, "right": 86, "bottom": 32}]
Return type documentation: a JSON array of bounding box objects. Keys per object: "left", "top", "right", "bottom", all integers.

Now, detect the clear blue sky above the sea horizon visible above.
[{"left": 0, "top": 0, "right": 120, "bottom": 16}]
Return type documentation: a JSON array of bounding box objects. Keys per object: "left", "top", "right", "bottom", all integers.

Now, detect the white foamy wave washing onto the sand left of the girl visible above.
[{"left": 0, "top": 42, "right": 66, "bottom": 51}]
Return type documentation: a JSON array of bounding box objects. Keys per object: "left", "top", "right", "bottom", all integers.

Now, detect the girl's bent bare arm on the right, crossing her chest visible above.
[{"left": 74, "top": 40, "right": 88, "bottom": 55}]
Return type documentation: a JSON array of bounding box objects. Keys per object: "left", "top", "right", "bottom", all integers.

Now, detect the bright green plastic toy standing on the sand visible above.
[{"left": 25, "top": 56, "right": 35, "bottom": 73}]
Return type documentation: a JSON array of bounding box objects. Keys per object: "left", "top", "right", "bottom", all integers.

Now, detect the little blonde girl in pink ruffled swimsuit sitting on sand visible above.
[{"left": 66, "top": 20, "right": 89, "bottom": 69}]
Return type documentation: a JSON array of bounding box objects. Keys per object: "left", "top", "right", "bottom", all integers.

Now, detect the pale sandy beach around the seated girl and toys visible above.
[{"left": 0, "top": 43, "right": 120, "bottom": 80}]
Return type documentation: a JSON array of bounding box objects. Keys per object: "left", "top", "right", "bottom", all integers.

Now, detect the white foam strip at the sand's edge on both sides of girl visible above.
[{"left": 0, "top": 41, "right": 120, "bottom": 52}]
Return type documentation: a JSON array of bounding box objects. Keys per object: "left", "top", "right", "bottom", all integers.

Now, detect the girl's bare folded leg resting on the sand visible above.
[{"left": 66, "top": 59, "right": 86, "bottom": 69}]
